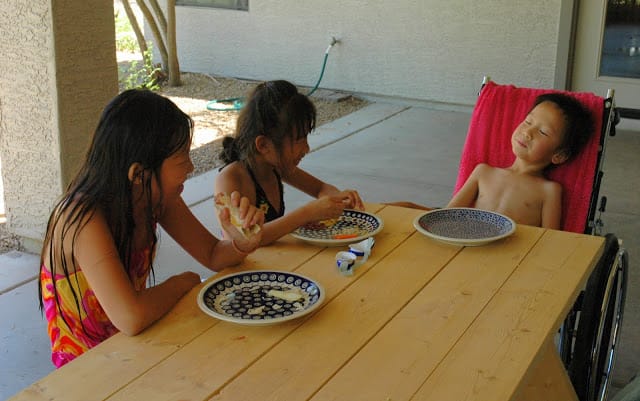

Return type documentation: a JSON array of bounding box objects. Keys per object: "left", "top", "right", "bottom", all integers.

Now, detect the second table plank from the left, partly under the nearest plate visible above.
[{"left": 101, "top": 208, "right": 416, "bottom": 401}]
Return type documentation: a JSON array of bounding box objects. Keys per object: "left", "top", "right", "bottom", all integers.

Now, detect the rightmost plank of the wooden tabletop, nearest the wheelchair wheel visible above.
[{"left": 412, "top": 230, "right": 604, "bottom": 401}]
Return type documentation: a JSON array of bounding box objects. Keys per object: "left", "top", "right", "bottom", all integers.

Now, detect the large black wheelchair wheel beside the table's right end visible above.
[{"left": 560, "top": 234, "right": 629, "bottom": 401}]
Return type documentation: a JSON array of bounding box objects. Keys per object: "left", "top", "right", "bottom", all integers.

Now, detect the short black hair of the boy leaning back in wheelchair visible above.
[{"left": 531, "top": 92, "right": 594, "bottom": 160}]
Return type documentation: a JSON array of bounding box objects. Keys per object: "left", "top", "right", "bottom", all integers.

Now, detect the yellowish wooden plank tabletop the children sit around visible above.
[{"left": 12, "top": 204, "right": 604, "bottom": 401}]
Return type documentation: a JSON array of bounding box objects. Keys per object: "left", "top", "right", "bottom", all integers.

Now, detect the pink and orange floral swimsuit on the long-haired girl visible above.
[{"left": 40, "top": 249, "right": 151, "bottom": 368}]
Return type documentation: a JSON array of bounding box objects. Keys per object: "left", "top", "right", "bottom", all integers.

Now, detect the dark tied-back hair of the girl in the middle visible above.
[{"left": 220, "top": 80, "right": 316, "bottom": 165}]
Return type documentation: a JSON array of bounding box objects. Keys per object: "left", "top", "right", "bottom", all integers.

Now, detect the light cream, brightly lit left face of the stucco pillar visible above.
[{"left": 0, "top": 0, "right": 61, "bottom": 247}]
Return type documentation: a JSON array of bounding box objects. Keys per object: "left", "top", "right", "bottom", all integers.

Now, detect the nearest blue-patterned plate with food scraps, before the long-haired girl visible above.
[{"left": 198, "top": 270, "right": 325, "bottom": 325}]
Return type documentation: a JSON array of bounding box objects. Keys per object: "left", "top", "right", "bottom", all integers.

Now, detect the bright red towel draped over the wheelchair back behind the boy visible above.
[{"left": 454, "top": 81, "right": 604, "bottom": 233}]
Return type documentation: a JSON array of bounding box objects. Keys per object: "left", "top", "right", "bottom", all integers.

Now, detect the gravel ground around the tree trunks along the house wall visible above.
[{"left": 0, "top": 73, "right": 367, "bottom": 254}]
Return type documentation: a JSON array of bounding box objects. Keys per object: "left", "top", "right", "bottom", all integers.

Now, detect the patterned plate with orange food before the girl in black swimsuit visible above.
[{"left": 291, "top": 209, "right": 383, "bottom": 246}]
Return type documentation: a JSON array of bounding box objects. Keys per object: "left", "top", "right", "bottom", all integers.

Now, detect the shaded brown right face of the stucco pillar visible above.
[{"left": 51, "top": 0, "right": 118, "bottom": 187}]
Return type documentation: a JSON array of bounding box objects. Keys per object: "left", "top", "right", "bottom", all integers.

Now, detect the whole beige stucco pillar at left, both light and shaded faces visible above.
[{"left": 0, "top": 0, "right": 118, "bottom": 252}]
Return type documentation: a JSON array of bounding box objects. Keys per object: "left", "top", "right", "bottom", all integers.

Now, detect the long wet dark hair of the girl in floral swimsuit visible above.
[{"left": 38, "top": 89, "right": 193, "bottom": 334}]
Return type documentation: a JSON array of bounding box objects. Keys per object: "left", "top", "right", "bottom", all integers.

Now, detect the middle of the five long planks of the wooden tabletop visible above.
[{"left": 212, "top": 209, "right": 462, "bottom": 400}]
